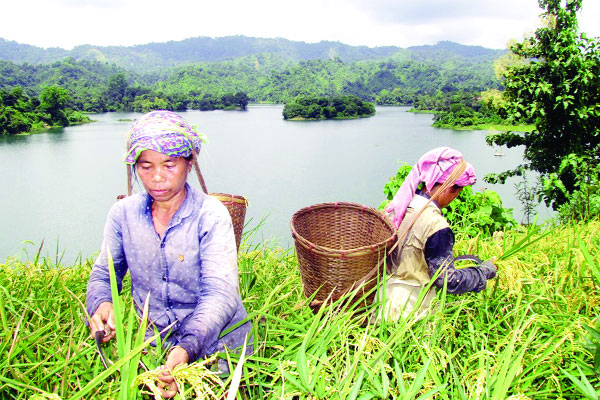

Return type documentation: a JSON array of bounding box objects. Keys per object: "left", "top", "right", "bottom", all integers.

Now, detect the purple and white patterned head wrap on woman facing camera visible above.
[{"left": 124, "top": 110, "right": 206, "bottom": 165}]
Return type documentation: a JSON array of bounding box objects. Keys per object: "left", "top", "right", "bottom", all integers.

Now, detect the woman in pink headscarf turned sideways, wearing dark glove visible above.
[{"left": 383, "top": 147, "right": 496, "bottom": 320}]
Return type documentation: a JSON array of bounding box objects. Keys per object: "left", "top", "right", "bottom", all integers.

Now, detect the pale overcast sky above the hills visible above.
[{"left": 0, "top": 0, "right": 600, "bottom": 49}]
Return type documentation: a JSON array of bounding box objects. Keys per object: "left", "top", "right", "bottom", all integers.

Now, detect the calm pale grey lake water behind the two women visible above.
[{"left": 0, "top": 105, "right": 550, "bottom": 264}]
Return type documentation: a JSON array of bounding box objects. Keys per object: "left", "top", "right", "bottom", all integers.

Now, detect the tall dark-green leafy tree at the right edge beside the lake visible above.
[{"left": 486, "top": 0, "right": 600, "bottom": 208}]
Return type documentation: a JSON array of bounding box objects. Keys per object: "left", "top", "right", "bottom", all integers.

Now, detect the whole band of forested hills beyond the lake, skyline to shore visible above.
[{"left": 0, "top": 36, "right": 502, "bottom": 122}]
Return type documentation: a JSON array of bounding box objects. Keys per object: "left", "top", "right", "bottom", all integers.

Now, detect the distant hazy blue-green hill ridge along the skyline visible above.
[{"left": 0, "top": 36, "right": 503, "bottom": 72}]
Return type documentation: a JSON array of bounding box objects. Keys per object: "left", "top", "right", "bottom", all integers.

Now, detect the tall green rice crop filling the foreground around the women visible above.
[{"left": 0, "top": 221, "right": 600, "bottom": 400}]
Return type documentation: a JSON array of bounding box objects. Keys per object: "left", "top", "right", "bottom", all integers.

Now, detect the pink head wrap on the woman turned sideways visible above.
[{"left": 385, "top": 147, "right": 477, "bottom": 227}]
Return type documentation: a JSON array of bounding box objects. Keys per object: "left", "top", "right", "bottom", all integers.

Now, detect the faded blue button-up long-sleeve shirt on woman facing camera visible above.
[{"left": 87, "top": 185, "right": 251, "bottom": 362}]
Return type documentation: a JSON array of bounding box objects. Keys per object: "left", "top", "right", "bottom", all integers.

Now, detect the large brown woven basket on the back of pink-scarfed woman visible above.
[{"left": 291, "top": 202, "right": 396, "bottom": 303}]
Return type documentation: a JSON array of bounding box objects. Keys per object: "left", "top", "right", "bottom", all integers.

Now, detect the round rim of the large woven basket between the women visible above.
[{"left": 290, "top": 201, "right": 397, "bottom": 258}]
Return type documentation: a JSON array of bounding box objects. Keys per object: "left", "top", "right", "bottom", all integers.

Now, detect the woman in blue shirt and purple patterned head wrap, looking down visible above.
[{"left": 87, "top": 111, "right": 250, "bottom": 397}]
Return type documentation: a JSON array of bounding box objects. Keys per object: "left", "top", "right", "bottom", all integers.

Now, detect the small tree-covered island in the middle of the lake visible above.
[{"left": 283, "top": 96, "right": 375, "bottom": 121}]
